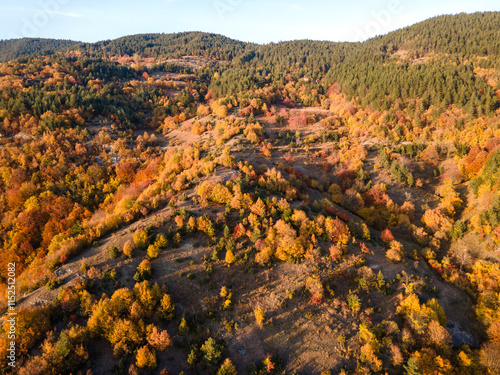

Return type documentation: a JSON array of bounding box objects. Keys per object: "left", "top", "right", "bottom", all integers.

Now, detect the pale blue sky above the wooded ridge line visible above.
[{"left": 0, "top": 0, "right": 500, "bottom": 43}]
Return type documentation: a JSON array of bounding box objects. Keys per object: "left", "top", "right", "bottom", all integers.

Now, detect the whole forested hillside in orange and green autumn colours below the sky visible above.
[{"left": 0, "top": 13, "right": 500, "bottom": 375}]
